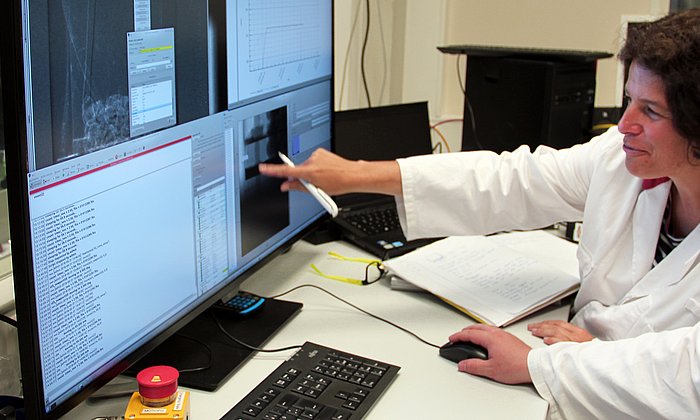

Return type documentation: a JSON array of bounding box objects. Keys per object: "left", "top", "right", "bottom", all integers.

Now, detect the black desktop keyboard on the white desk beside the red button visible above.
[{"left": 222, "top": 342, "right": 400, "bottom": 420}]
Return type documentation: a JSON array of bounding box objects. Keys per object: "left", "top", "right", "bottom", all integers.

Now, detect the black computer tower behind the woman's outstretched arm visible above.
[{"left": 462, "top": 55, "right": 596, "bottom": 152}]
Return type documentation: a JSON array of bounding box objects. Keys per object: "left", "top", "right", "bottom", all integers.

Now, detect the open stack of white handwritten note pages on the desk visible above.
[{"left": 385, "top": 232, "right": 579, "bottom": 327}]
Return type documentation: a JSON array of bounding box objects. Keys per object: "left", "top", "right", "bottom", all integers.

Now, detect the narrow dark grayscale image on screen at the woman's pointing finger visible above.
[{"left": 241, "top": 107, "right": 289, "bottom": 255}]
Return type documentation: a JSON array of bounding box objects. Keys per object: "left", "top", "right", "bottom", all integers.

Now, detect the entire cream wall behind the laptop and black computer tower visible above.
[{"left": 335, "top": 0, "right": 670, "bottom": 150}]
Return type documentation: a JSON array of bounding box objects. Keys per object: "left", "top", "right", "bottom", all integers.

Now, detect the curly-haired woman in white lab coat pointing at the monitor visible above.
[{"left": 260, "top": 9, "right": 700, "bottom": 418}]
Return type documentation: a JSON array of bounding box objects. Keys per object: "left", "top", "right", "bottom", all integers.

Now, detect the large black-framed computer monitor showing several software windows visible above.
[{"left": 0, "top": 0, "right": 333, "bottom": 419}]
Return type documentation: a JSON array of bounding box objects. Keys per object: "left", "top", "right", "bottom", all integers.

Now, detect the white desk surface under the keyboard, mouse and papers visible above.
[{"left": 65, "top": 241, "right": 570, "bottom": 419}]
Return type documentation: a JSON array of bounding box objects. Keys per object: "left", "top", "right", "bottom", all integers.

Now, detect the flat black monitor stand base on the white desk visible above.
[{"left": 124, "top": 299, "right": 302, "bottom": 391}]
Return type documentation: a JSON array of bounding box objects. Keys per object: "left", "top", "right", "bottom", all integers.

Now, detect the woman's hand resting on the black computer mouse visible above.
[{"left": 450, "top": 324, "right": 532, "bottom": 384}]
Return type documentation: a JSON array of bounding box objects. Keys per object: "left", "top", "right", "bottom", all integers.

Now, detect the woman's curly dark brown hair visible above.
[{"left": 619, "top": 8, "right": 700, "bottom": 159}]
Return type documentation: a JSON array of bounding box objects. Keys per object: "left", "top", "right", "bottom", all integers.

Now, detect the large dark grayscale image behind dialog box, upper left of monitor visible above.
[{"left": 30, "top": 0, "right": 221, "bottom": 168}]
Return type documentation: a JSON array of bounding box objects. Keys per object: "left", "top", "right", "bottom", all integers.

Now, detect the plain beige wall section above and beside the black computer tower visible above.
[{"left": 442, "top": 0, "right": 669, "bottom": 113}]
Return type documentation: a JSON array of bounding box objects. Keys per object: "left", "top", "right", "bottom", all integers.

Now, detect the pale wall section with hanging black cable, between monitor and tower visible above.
[{"left": 335, "top": 0, "right": 448, "bottom": 115}]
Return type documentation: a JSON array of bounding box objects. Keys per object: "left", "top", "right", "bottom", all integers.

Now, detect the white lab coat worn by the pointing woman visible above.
[{"left": 397, "top": 128, "right": 700, "bottom": 419}]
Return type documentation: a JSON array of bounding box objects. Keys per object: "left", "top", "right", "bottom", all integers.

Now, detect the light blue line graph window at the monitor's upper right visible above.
[{"left": 227, "top": 0, "right": 332, "bottom": 107}]
